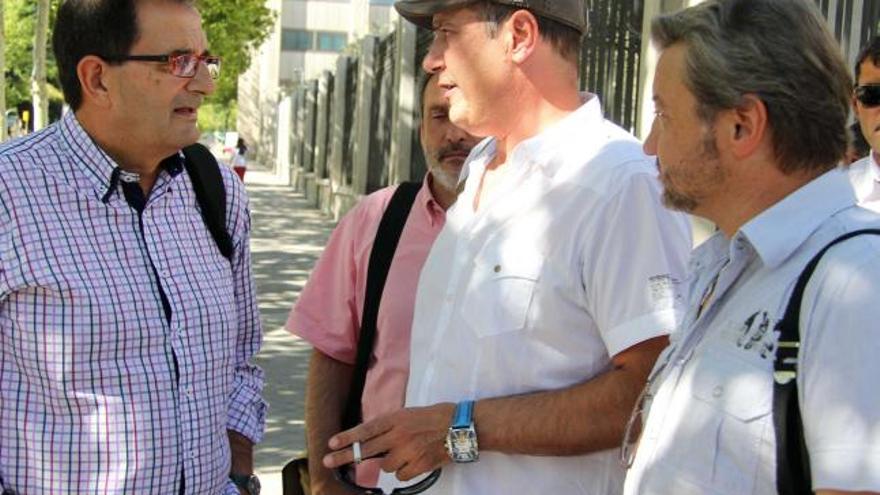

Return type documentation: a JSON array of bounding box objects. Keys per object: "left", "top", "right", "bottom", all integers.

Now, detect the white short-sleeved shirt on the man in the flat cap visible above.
[{"left": 396, "top": 96, "right": 691, "bottom": 495}]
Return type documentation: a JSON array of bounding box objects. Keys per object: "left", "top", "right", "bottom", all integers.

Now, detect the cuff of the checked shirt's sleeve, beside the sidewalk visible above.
[{"left": 226, "top": 366, "right": 268, "bottom": 444}]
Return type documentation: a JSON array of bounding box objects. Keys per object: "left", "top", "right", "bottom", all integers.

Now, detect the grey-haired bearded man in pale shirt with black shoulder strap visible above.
[{"left": 622, "top": 0, "right": 880, "bottom": 495}]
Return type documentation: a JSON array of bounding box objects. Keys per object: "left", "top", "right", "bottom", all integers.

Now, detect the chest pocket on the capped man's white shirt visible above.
[{"left": 462, "top": 244, "right": 544, "bottom": 337}]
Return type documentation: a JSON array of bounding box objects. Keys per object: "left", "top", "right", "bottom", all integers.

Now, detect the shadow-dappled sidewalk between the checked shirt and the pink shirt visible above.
[{"left": 245, "top": 165, "right": 335, "bottom": 495}]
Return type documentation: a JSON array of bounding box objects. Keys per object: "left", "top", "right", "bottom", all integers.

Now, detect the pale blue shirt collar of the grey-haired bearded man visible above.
[{"left": 734, "top": 168, "right": 856, "bottom": 268}]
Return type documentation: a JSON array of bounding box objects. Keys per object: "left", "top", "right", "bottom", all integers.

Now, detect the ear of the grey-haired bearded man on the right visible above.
[{"left": 716, "top": 95, "right": 767, "bottom": 158}]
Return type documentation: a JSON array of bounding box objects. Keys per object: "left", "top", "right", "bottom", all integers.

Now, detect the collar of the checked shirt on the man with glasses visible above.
[{"left": 60, "top": 112, "right": 184, "bottom": 202}]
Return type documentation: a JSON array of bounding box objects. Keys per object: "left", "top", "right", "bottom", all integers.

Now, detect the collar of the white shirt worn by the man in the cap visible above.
[{"left": 462, "top": 93, "right": 605, "bottom": 177}]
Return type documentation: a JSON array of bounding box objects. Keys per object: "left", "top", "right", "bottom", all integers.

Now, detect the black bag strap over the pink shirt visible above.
[{"left": 342, "top": 182, "right": 422, "bottom": 430}]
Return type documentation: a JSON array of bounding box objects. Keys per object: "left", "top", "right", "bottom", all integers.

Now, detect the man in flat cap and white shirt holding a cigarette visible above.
[{"left": 325, "top": 0, "right": 691, "bottom": 495}]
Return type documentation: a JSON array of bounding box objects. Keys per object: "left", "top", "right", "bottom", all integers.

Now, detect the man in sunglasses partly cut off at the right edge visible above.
[{"left": 850, "top": 36, "right": 880, "bottom": 212}]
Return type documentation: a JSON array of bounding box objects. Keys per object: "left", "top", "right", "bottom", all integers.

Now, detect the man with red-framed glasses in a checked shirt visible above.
[{"left": 0, "top": 0, "right": 266, "bottom": 495}]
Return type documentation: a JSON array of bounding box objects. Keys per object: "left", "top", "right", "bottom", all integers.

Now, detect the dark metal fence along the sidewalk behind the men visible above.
[{"left": 282, "top": 0, "right": 880, "bottom": 216}]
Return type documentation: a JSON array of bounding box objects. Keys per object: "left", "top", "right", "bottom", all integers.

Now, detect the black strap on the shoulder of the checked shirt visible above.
[{"left": 183, "top": 143, "right": 235, "bottom": 260}]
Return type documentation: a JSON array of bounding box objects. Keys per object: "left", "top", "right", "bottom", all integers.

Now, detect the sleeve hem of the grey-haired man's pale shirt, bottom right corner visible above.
[{"left": 810, "top": 450, "right": 880, "bottom": 492}]
